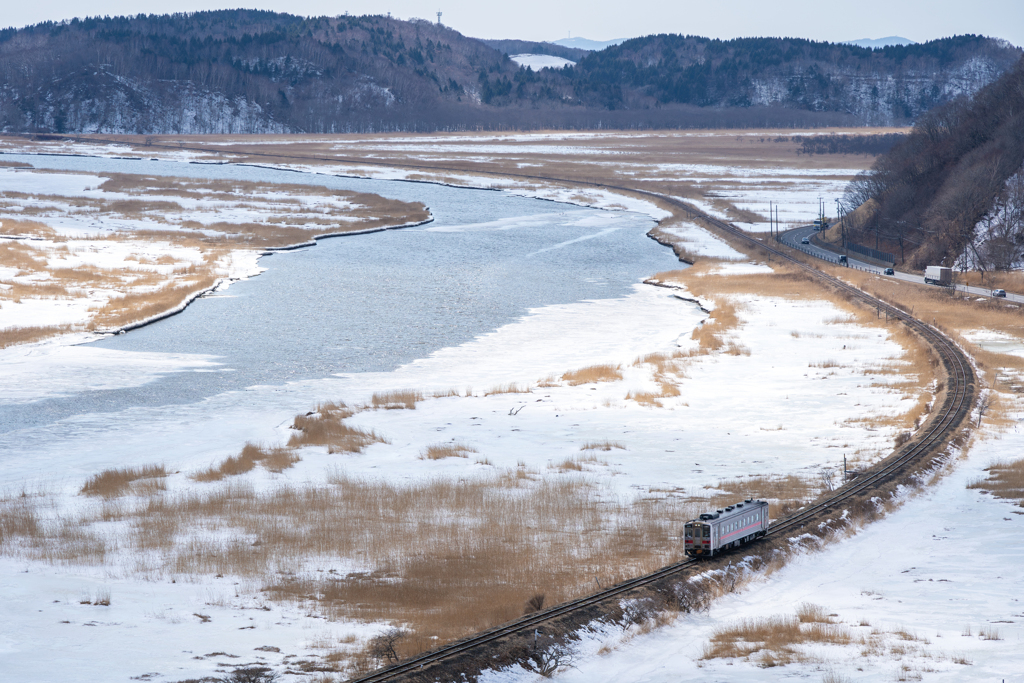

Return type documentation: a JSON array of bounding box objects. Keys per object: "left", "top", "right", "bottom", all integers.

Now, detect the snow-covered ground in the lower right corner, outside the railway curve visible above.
[{"left": 483, "top": 414, "right": 1024, "bottom": 683}]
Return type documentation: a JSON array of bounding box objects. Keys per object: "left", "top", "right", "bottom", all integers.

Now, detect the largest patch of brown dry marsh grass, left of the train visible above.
[{"left": 0, "top": 469, "right": 700, "bottom": 655}]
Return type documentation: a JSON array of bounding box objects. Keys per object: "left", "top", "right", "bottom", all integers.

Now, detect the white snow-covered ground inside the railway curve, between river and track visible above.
[{"left": 0, "top": 263, "right": 929, "bottom": 681}]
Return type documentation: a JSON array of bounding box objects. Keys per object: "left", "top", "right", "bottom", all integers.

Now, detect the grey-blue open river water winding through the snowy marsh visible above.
[{"left": 0, "top": 155, "right": 678, "bottom": 440}]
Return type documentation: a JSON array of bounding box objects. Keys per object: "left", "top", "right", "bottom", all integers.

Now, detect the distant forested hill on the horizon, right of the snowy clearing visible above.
[{"left": 569, "top": 35, "right": 1021, "bottom": 125}]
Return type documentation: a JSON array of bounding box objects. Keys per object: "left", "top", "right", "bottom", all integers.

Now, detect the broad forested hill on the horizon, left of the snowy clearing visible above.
[{"left": 0, "top": 9, "right": 518, "bottom": 133}]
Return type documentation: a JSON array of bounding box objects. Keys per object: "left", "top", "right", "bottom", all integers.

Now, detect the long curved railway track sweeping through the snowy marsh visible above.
[{"left": 16, "top": 136, "right": 976, "bottom": 683}]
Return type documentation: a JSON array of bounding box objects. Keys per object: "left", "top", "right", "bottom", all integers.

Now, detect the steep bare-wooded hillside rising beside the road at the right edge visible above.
[{"left": 847, "top": 59, "right": 1024, "bottom": 270}]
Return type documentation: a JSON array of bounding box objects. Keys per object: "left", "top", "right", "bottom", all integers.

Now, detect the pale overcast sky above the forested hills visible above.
[{"left": 0, "top": 0, "right": 1024, "bottom": 45}]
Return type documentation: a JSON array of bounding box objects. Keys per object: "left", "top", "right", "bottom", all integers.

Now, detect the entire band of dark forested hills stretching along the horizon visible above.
[{"left": 0, "top": 10, "right": 1021, "bottom": 133}]
